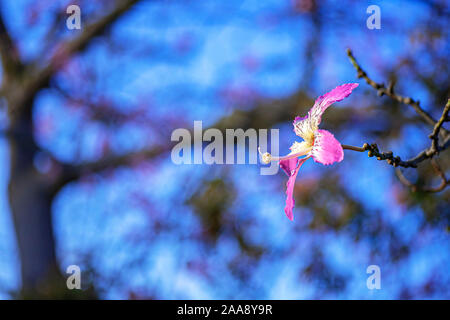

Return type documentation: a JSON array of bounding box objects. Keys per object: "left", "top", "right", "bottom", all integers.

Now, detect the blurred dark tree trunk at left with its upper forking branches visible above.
[{"left": 0, "top": 0, "right": 139, "bottom": 298}]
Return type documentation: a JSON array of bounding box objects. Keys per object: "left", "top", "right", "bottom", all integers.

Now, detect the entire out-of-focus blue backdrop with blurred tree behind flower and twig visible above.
[{"left": 0, "top": 0, "right": 450, "bottom": 299}]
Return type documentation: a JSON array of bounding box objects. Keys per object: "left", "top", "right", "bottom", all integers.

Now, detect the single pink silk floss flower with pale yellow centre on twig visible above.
[{"left": 258, "top": 83, "right": 358, "bottom": 221}]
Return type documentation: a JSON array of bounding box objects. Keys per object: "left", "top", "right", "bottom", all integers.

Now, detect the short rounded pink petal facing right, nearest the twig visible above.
[{"left": 311, "top": 129, "right": 344, "bottom": 165}]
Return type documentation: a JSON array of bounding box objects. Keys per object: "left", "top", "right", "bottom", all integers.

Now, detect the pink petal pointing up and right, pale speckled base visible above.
[{"left": 294, "top": 83, "right": 359, "bottom": 140}]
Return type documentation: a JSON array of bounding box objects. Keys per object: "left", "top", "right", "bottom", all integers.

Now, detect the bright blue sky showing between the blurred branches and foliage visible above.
[{"left": 0, "top": 1, "right": 450, "bottom": 299}]
